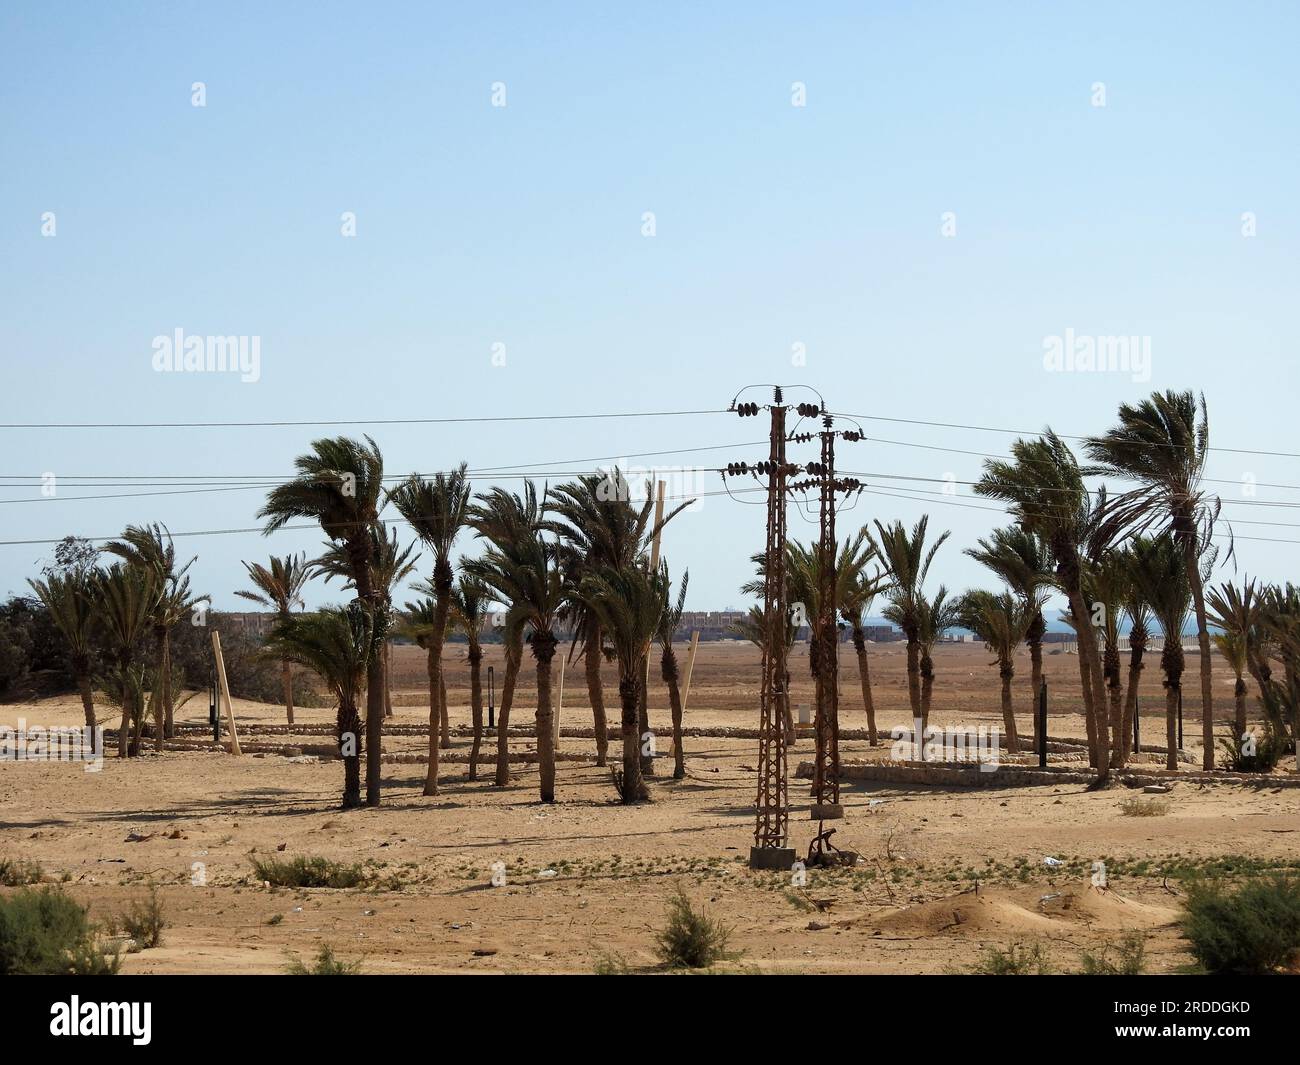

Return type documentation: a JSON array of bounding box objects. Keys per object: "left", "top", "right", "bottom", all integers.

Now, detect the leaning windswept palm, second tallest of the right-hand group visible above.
[{"left": 975, "top": 429, "right": 1110, "bottom": 782}]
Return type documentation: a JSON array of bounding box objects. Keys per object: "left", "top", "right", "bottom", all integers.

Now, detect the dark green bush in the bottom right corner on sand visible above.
[{"left": 1182, "top": 876, "right": 1300, "bottom": 974}]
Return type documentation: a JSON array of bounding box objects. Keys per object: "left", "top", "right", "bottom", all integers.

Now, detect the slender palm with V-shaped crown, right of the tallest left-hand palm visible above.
[{"left": 389, "top": 463, "right": 469, "bottom": 795}]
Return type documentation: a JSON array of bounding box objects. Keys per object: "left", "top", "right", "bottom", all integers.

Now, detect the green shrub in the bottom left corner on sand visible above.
[{"left": 0, "top": 887, "right": 121, "bottom": 977}]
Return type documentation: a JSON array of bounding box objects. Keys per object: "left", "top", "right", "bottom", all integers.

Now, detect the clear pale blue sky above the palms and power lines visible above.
[{"left": 0, "top": 3, "right": 1300, "bottom": 621}]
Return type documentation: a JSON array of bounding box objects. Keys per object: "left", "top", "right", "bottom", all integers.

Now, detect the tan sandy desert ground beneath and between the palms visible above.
[{"left": 0, "top": 644, "right": 1300, "bottom": 973}]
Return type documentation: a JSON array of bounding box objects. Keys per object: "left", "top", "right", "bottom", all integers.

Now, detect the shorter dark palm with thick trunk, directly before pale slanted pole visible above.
[{"left": 579, "top": 564, "right": 668, "bottom": 804}]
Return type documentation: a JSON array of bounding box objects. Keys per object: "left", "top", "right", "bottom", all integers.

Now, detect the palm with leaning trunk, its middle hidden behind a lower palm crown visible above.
[{"left": 462, "top": 481, "right": 542, "bottom": 788}]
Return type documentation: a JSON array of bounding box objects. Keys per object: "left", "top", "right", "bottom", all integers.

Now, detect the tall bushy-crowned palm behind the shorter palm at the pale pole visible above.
[{"left": 542, "top": 467, "right": 694, "bottom": 766}]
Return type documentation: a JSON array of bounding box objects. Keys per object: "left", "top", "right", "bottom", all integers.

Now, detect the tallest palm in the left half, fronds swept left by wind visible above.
[{"left": 257, "top": 437, "right": 389, "bottom": 806}]
